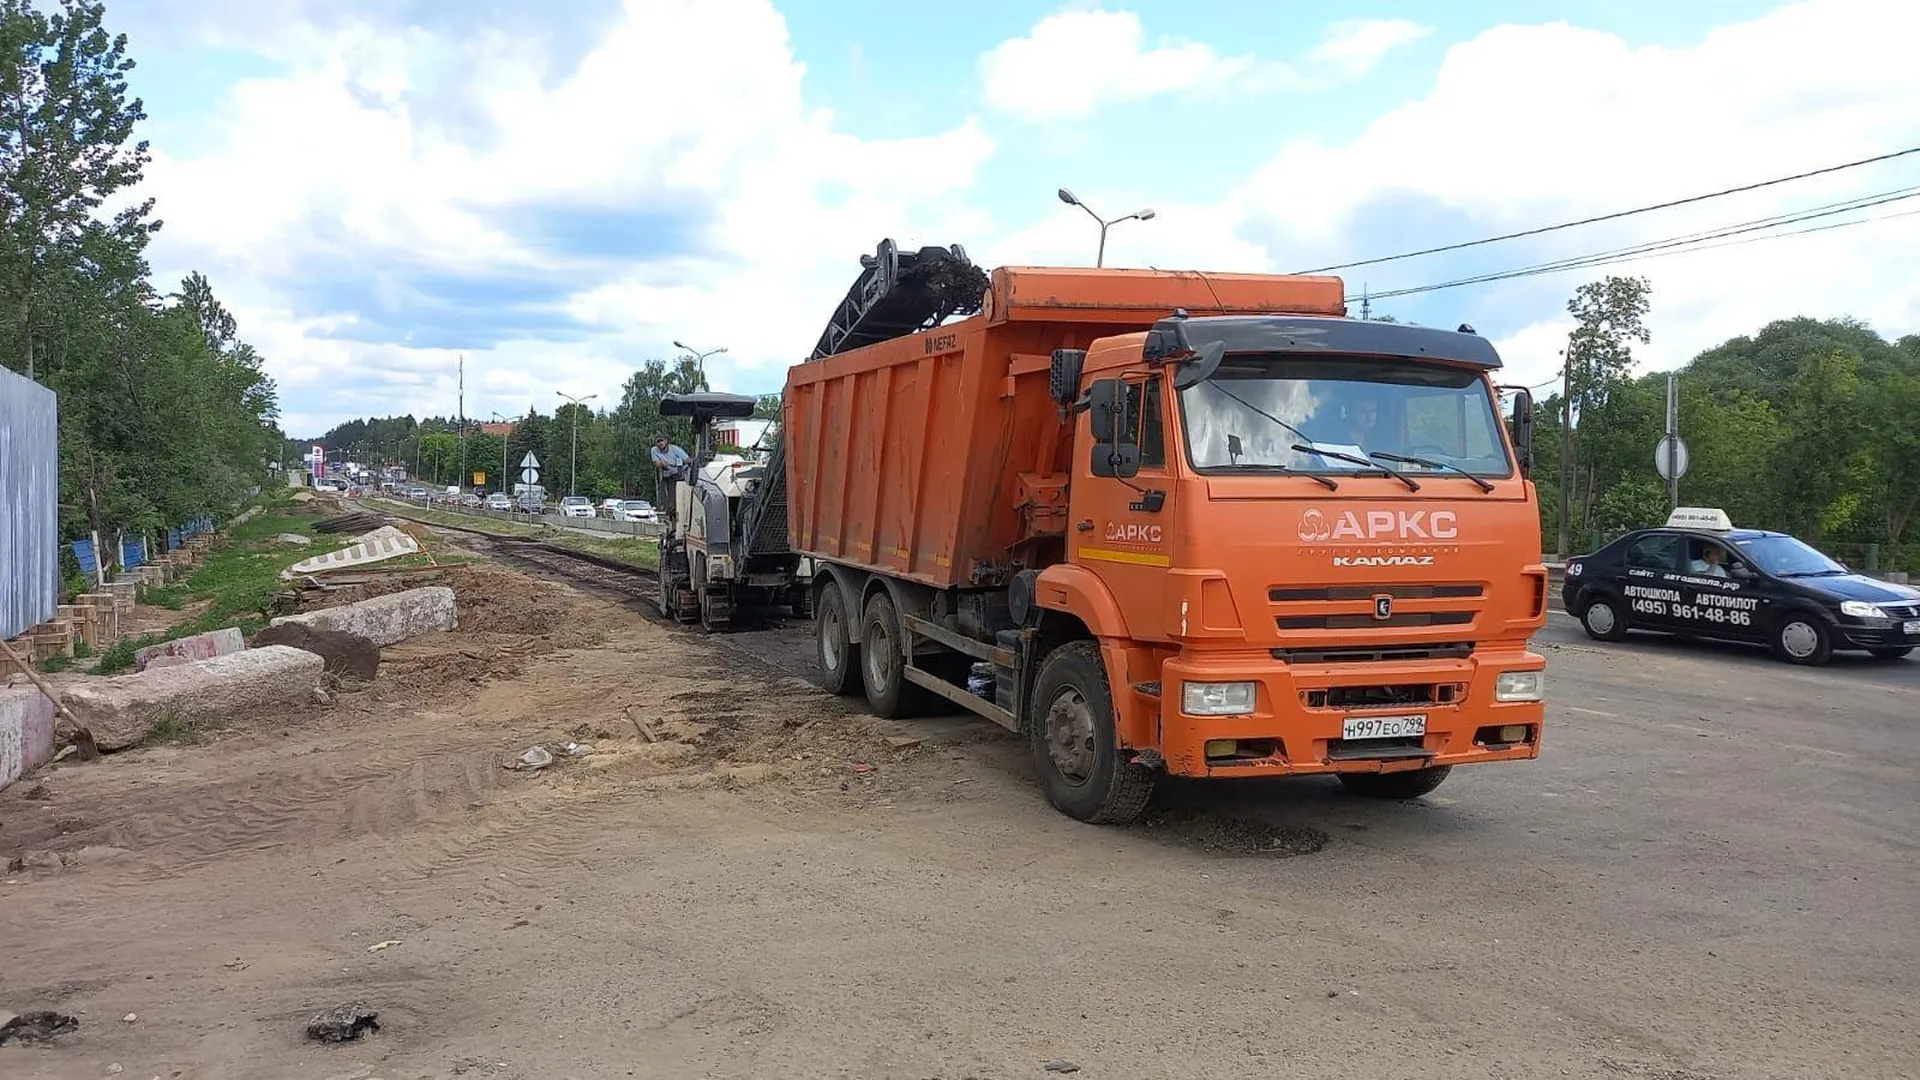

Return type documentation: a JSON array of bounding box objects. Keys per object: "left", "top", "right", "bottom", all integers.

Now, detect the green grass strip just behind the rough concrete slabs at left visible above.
[{"left": 94, "top": 498, "right": 351, "bottom": 675}]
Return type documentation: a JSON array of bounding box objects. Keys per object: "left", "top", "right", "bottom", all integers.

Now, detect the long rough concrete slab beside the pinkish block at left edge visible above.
[{"left": 63, "top": 646, "right": 324, "bottom": 749}]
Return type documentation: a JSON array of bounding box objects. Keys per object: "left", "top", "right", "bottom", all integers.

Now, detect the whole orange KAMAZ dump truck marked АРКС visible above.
[{"left": 783, "top": 239, "right": 1548, "bottom": 822}]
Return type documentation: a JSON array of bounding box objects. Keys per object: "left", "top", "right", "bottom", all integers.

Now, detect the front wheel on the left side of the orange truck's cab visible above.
[{"left": 1029, "top": 642, "right": 1158, "bottom": 824}]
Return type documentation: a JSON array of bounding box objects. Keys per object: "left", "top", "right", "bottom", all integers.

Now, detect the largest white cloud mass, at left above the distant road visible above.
[{"left": 148, "top": 0, "right": 995, "bottom": 430}]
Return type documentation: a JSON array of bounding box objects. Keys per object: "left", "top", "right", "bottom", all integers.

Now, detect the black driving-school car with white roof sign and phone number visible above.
[{"left": 1561, "top": 507, "right": 1920, "bottom": 663}]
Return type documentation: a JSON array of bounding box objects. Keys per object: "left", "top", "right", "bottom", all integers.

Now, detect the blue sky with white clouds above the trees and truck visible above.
[{"left": 108, "top": 0, "right": 1920, "bottom": 436}]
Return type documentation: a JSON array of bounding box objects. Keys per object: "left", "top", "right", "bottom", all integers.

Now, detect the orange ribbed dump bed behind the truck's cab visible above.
[{"left": 783, "top": 267, "right": 1346, "bottom": 586}]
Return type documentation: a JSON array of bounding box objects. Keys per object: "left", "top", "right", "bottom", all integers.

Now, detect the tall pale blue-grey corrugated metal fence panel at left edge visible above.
[{"left": 0, "top": 367, "right": 60, "bottom": 638}]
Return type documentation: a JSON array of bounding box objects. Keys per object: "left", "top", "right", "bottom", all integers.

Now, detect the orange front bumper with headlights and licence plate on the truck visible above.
[{"left": 1160, "top": 646, "right": 1546, "bottom": 776}]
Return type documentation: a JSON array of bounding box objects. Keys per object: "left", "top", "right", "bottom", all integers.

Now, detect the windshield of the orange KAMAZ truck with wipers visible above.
[{"left": 1181, "top": 354, "right": 1513, "bottom": 477}]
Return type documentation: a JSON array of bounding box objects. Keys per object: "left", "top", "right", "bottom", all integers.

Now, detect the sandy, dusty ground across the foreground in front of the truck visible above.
[{"left": 0, "top": 549, "right": 1920, "bottom": 1080}]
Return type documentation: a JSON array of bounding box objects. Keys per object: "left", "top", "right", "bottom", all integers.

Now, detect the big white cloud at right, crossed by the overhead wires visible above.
[{"left": 995, "top": 0, "right": 1920, "bottom": 382}]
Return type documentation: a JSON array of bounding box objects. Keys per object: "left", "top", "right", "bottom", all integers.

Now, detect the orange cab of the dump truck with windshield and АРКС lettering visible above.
[{"left": 1025, "top": 315, "right": 1548, "bottom": 813}]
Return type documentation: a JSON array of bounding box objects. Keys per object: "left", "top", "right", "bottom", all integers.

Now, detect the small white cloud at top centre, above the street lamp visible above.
[{"left": 979, "top": 8, "right": 1427, "bottom": 121}]
